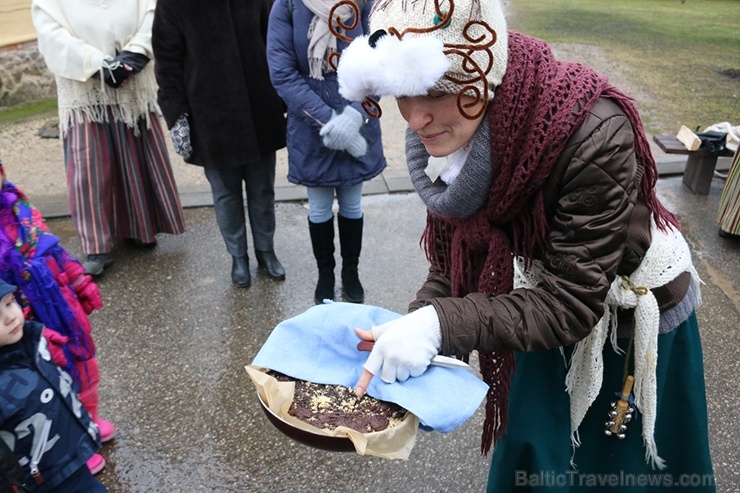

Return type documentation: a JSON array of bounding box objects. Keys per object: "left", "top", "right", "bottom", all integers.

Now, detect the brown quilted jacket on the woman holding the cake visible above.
[{"left": 409, "top": 99, "right": 690, "bottom": 355}]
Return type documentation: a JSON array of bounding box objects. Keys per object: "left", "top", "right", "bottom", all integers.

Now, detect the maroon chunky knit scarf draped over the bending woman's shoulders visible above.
[{"left": 422, "top": 32, "right": 678, "bottom": 454}]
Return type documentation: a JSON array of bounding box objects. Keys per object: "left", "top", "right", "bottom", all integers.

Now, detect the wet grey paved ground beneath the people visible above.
[{"left": 36, "top": 171, "right": 740, "bottom": 493}]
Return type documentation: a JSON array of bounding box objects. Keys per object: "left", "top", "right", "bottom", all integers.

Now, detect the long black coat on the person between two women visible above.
[{"left": 152, "top": 0, "right": 285, "bottom": 168}]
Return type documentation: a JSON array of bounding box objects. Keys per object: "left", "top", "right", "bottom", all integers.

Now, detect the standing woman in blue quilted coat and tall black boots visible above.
[{"left": 267, "top": 0, "right": 386, "bottom": 304}]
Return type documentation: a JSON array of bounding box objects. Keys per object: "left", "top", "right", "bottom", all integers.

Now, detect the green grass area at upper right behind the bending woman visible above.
[{"left": 509, "top": 0, "right": 740, "bottom": 133}]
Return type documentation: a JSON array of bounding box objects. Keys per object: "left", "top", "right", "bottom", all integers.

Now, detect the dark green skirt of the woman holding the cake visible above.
[{"left": 487, "top": 313, "right": 715, "bottom": 493}]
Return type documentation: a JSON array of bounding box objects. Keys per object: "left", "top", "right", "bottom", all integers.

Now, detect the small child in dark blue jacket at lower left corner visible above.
[{"left": 0, "top": 280, "right": 108, "bottom": 493}]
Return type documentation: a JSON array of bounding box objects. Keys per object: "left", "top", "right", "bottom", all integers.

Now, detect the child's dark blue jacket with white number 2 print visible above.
[{"left": 0, "top": 321, "right": 100, "bottom": 492}]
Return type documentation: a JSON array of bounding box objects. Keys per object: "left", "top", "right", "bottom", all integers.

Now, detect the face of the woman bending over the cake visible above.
[{"left": 396, "top": 90, "right": 487, "bottom": 157}]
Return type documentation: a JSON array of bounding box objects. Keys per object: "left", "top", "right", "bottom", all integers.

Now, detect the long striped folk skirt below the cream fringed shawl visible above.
[{"left": 64, "top": 113, "right": 185, "bottom": 254}]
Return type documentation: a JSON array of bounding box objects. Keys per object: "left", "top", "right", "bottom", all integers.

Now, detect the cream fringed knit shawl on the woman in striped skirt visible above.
[{"left": 31, "top": 0, "right": 159, "bottom": 135}]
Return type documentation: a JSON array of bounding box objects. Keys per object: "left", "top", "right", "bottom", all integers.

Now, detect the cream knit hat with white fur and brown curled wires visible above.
[{"left": 337, "top": 0, "right": 508, "bottom": 109}]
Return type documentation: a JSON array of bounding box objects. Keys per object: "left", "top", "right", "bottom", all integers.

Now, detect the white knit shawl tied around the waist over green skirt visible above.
[{"left": 514, "top": 217, "right": 701, "bottom": 469}]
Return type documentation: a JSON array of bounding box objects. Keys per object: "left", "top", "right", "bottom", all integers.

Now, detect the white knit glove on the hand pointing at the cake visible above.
[{"left": 364, "top": 305, "right": 442, "bottom": 383}]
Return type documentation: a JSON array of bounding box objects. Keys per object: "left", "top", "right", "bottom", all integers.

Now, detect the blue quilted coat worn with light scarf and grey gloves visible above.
[{"left": 267, "top": 0, "right": 386, "bottom": 187}]
